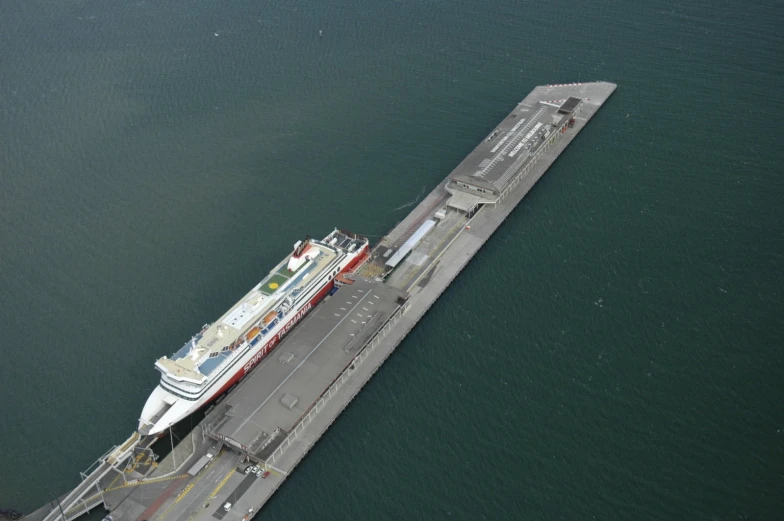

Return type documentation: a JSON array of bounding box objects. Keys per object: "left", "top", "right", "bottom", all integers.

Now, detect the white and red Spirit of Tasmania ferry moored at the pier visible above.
[{"left": 139, "top": 230, "right": 369, "bottom": 436}]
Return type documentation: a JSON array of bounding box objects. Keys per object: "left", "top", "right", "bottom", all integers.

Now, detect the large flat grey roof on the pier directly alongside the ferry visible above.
[{"left": 207, "top": 278, "right": 404, "bottom": 459}]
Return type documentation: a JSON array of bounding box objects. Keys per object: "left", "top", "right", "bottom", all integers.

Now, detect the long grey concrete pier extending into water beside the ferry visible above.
[{"left": 27, "top": 82, "right": 616, "bottom": 521}]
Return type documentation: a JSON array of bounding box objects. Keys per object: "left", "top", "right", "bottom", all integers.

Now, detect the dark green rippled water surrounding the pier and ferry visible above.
[{"left": 0, "top": 0, "right": 784, "bottom": 521}]
